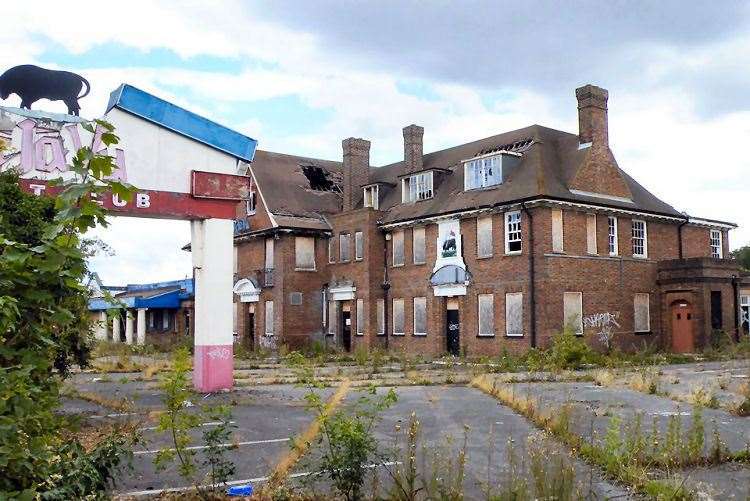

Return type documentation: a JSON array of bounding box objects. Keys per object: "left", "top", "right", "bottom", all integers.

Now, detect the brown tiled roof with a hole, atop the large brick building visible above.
[{"left": 252, "top": 121, "right": 684, "bottom": 228}]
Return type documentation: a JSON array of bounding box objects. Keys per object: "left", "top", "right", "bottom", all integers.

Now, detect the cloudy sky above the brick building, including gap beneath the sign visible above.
[{"left": 0, "top": 0, "right": 750, "bottom": 283}]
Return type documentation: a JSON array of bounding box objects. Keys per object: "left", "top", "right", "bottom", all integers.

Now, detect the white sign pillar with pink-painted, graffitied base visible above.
[{"left": 190, "top": 219, "right": 234, "bottom": 391}]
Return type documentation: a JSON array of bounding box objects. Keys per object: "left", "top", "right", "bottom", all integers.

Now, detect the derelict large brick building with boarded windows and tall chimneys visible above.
[{"left": 235, "top": 85, "right": 750, "bottom": 356}]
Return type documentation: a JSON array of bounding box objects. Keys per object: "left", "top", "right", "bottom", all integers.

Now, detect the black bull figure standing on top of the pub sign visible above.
[{"left": 0, "top": 64, "right": 91, "bottom": 116}]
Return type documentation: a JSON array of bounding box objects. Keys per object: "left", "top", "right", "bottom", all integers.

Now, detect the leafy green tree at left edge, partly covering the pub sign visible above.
[{"left": 0, "top": 122, "right": 137, "bottom": 499}]
